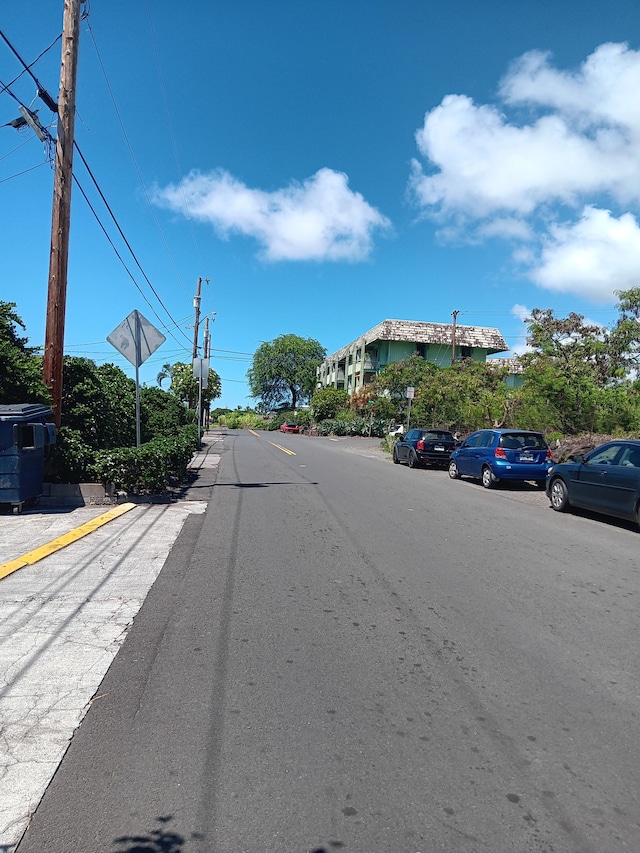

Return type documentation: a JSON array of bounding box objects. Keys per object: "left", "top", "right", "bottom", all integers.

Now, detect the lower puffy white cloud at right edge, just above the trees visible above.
[{"left": 531, "top": 207, "right": 640, "bottom": 302}]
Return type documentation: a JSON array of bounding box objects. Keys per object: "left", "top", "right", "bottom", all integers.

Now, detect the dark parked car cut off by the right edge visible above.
[{"left": 547, "top": 440, "right": 640, "bottom": 524}]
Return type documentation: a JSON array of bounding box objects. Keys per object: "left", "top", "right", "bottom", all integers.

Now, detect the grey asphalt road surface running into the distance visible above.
[{"left": 18, "top": 431, "right": 640, "bottom": 853}]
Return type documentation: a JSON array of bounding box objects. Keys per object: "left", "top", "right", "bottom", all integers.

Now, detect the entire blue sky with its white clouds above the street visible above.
[{"left": 0, "top": 0, "right": 640, "bottom": 408}]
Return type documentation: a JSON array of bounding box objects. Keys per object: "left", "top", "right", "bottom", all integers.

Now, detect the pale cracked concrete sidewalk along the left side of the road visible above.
[{"left": 0, "top": 433, "right": 223, "bottom": 853}]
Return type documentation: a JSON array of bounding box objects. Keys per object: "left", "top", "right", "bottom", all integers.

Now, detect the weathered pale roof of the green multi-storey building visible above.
[{"left": 326, "top": 320, "right": 509, "bottom": 361}]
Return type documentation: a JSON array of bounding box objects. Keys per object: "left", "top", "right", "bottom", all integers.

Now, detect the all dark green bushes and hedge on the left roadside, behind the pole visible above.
[{"left": 0, "top": 301, "right": 220, "bottom": 494}]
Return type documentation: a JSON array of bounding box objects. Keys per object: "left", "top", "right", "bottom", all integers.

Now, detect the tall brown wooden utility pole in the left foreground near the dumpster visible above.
[{"left": 42, "top": 0, "right": 82, "bottom": 427}]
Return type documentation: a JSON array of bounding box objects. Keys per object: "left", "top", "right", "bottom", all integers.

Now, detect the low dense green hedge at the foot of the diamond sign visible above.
[{"left": 90, "top": 424, "right": 198, "bottom": 495}]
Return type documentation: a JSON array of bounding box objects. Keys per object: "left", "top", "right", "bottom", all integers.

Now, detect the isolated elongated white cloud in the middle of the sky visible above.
[{"left": 154, "top": 169, "right": 391, "bottom": 261}]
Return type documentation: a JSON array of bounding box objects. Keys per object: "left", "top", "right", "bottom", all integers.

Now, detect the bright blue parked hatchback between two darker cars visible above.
[{"left": 449, "top": 429, "right": 551, "bottom": 489}]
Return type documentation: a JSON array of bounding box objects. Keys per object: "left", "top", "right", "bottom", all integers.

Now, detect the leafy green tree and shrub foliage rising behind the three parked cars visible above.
[{"left": 364, "top": 288, "right": 640, "bottom": 435}]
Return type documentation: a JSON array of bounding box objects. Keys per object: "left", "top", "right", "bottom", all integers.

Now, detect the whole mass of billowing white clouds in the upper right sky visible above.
[{"left": 409, "top": 44, "right": 640, "bottom": 302}]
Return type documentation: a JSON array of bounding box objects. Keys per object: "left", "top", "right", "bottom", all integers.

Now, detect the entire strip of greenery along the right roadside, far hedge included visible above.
[{"left": 230, "top": 288, "right": 640, "bottom": 457}]
